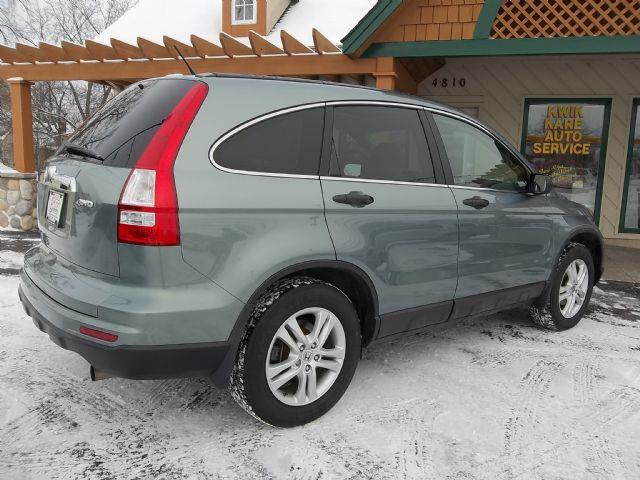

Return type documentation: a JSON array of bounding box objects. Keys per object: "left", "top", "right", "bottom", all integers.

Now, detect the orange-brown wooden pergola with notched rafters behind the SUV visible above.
[{"left": 0, "top": 29, "right": 424, "bottom": 172}]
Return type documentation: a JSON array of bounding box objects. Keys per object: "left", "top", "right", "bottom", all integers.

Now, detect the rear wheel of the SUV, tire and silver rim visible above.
[{"left": 230, "top": 277, "right": 361, "bottom": 427}]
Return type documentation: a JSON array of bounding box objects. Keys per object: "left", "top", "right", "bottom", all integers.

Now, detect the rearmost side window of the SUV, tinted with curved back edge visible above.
[{"left": 213, "top": 108, "right": 324, "bottom": 175}]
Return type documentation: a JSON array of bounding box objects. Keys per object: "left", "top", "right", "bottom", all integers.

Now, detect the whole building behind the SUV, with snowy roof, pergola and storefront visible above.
[{"left": 0, "top": 0, "right": 640, "bottom": 247}]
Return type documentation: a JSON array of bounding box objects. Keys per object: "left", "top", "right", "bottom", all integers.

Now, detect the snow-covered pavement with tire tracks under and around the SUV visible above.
[{"left": 0, "top": 254, "right": 640, "bottom": 479}]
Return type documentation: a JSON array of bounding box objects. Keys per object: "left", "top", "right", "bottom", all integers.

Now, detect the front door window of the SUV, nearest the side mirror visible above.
[{"left": 433, "top": 114, "right": 528, "bottom": 191}]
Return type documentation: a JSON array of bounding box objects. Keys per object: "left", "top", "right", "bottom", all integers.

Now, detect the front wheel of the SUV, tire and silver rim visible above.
[{"left": 529, "top": 243, "right": 595, "bottom": 331}]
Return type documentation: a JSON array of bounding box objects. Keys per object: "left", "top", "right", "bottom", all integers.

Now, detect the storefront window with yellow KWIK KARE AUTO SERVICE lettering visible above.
[{"left": 522, "top": 99, "right": 610, "bottom": 223}]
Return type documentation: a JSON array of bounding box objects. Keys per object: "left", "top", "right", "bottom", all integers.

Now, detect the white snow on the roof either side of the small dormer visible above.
[{"left": 94, "top": 0, "right": 376, "bottom": 45}]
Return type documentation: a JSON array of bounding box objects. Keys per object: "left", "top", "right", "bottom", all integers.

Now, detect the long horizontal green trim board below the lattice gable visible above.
[{"left": 362, "top": 35, "right": 640, "bottom": 57}]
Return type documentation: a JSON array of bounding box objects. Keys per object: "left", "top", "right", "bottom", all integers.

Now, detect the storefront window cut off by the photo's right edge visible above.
[{"left": 620, "top": 99, "right": 640, "bottom": 233}]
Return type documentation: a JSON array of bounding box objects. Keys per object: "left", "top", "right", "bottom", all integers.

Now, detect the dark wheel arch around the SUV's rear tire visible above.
[{"left": 212, "top": 260, "right": 380, "bottom": 388}]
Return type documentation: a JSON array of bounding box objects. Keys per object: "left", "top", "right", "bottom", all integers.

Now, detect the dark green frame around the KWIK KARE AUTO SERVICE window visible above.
[{"left": 520, "top": 97, "right": 611, "bottom": 226}]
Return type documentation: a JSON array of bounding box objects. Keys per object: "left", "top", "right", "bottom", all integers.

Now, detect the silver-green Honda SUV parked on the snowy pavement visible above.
[{"left": 20, "top": 75, "right": 602, "bottom": 426}]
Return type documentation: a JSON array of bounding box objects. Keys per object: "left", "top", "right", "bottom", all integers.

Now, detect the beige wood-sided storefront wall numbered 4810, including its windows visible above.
[{"left": 418, "top": 55, "right": 640, "bottom": 244}]
